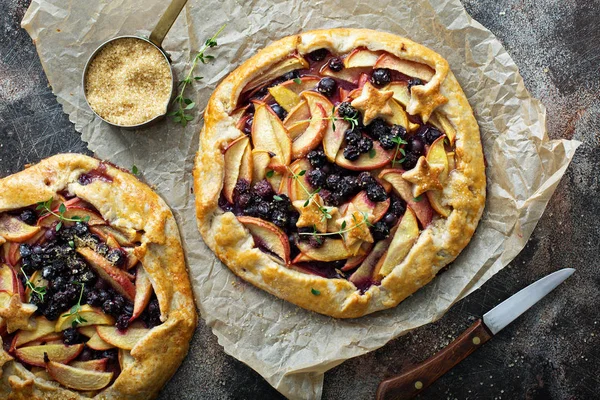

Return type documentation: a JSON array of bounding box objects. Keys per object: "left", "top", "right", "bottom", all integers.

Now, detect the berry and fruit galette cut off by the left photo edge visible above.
[{"left": 0, "top": 154, "right": 196, "bottom": 399}]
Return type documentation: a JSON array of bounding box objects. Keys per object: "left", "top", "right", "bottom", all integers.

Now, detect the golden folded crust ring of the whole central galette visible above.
[{"left": 194, "top": 29, "right": 485, "bottom": 318}]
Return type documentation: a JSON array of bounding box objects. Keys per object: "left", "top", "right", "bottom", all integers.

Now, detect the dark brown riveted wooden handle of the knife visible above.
[{"left": 377, "top": 320, "right": 492, "bottom": 400}]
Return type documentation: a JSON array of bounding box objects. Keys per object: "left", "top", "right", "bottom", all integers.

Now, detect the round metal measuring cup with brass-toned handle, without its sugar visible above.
[{"left": 82, "top": 0, "right": 187, "bottom": 130}]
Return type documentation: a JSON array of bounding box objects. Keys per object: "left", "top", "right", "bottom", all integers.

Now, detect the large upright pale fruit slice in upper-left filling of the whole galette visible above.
[{"left": 252, "top": 102, "right": 292, "bottom": 172}]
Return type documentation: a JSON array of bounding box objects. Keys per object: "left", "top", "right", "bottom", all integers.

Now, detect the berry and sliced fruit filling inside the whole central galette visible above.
[{"left": 219, "top": 48, "right": 456, "bottom": 291}]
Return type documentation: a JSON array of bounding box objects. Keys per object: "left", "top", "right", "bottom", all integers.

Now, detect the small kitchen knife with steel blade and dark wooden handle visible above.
[{"left": 377, "top": 268, "right": 575, "bottom": 400}]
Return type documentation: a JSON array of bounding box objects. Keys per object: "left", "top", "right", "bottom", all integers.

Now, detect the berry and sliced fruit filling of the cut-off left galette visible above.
[{"left": 0, "top": 195, "right": 161, "bottom": 392}]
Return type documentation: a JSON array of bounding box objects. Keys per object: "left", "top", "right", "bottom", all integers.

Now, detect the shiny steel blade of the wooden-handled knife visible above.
[{"left": 483, "top": 268, "right": 575, "bottom": 335}]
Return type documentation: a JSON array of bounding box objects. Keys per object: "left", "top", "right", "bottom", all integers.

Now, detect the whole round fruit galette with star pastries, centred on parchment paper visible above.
[{"left": 194, "top": 29, "right": 485, "bottom": 318}]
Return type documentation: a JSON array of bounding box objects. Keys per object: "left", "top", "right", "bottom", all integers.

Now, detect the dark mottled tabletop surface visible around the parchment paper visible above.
[{"left": 0, "top": 0, "right": 600, "bottom": 399}]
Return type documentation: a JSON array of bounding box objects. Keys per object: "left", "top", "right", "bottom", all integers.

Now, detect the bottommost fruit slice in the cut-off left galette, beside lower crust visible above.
[{"left": 46, "top": 361, "right": 113, "bottom": 390}]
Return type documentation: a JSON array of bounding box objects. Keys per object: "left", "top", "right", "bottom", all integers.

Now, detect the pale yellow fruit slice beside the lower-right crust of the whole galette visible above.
[{"left": 373, "top": 207, "right": 419, "bottom": 280}]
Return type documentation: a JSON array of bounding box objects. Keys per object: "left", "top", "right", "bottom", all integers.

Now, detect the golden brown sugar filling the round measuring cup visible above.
[{"left": 85, "top": 38, "right": 172, "bottom": 126}]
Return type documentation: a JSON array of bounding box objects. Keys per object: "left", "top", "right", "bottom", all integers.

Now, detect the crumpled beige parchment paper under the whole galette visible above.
[{"left": 23, "top": 0, "right": 579, "bottom": 398}]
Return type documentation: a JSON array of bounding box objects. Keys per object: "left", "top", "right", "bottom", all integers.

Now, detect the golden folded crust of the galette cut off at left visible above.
[{"left": 0, "top": 154, "right": 197, "bottom": 399}]
